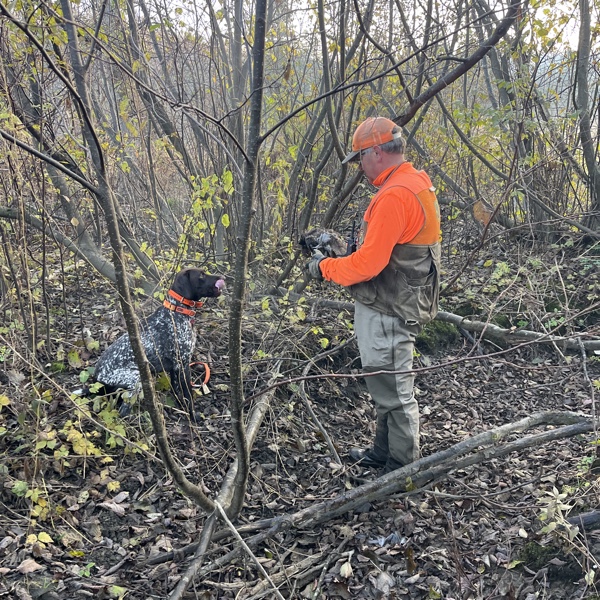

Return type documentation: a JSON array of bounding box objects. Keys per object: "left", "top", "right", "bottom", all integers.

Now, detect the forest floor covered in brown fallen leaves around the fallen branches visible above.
[{"left": 0, "top": 258, "right": 600, "bottom": 600}]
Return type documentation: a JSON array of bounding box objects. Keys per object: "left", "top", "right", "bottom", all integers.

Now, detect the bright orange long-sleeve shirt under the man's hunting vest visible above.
[{"left": 319, "top": 162, "right": 433, "bottom": 286}]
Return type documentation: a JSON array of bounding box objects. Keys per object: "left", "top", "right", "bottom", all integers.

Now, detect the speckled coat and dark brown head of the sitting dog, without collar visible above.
[{"left": 94, "top": 268, "right": 225, "bottom": 414}]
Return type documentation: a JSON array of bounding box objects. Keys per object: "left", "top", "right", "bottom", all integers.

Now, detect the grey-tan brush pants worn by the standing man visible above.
[{"left": 354, "top": 302, "right": 421, "bottom": 471}]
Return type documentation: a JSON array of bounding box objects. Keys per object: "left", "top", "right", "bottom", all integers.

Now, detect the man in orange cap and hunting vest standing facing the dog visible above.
[{"left": 307, "top": 117, "right": 441, "bottom": 473}]
